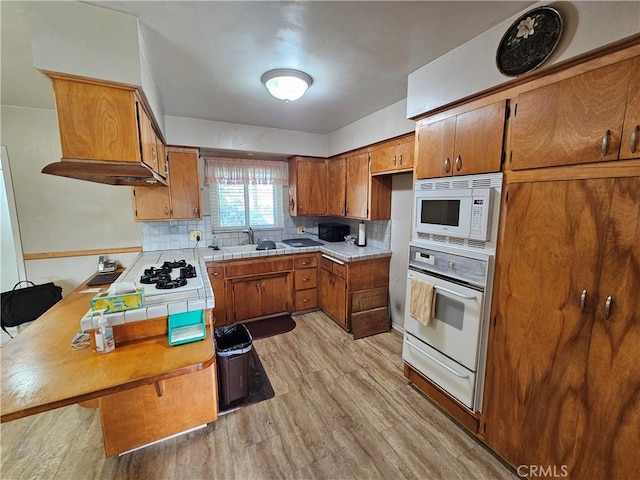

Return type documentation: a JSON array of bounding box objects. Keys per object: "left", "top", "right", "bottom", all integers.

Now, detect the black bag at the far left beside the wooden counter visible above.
[{"left": 0, "top": 280, "right": 62, "bottom": 338}]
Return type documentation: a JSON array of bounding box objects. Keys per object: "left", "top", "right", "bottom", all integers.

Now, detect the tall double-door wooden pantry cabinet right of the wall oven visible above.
[{"left": 480, "top": 177, "right": 640, "bottom": 479}]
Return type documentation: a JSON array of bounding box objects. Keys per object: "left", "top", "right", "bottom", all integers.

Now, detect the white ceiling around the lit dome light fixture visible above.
[{"left": 0, "top": 0, "right": 534, "bottom": 134}]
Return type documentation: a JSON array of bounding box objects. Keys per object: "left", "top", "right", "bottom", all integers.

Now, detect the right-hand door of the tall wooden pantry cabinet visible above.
[{"left": 571, "top": 177, "right": 640, "bottom": 478}]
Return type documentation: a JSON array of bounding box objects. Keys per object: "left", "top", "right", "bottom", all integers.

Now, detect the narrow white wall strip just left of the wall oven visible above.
[{"left": 389, "top": 173, "right": 413, "bottom": 329}]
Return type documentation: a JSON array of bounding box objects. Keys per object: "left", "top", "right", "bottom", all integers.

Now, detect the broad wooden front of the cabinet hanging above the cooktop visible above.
[{"left": 51, "top": 76, "right": 140, "bottom": 163}]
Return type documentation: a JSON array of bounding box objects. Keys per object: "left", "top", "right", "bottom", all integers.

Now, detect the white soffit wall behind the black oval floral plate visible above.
[{"left": 406, "top": 1, "right": 640, "bottom": 118}]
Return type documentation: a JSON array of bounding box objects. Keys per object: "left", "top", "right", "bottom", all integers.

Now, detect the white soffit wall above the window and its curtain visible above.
[{"left": 164, "top": 115, "right": 327, "bottom": 157}]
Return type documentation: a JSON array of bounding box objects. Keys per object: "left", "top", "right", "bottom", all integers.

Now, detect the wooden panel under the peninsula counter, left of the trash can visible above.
[{"left": 98, "top": 363, "right": 218, "bottom": 457}]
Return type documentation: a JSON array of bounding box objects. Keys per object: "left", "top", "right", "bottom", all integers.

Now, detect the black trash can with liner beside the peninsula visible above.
[{"left": 213, "top": 323, "right": 253, "bottom": 410}]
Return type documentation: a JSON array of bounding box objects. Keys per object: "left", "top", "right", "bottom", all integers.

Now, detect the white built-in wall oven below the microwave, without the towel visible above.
[{"left": 402, "top": 246, "right": 493, "bottom": 411}]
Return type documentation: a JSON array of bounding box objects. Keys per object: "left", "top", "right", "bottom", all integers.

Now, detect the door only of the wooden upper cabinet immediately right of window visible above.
[{"left": 295, "top": 159, "right": 327, "bottom": 215}]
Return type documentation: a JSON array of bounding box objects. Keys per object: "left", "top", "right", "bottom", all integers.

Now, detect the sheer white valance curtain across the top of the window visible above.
[{"left": 204, "top": 157, "right": 289, "bottom": 185}]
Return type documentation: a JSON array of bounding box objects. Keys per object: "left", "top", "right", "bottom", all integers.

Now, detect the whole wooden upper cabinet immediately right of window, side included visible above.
[{"left": 289, "top": 157, "right": 327, "bottom": 216}]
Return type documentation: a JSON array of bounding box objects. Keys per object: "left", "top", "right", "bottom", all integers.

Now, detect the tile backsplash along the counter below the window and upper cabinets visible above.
[{"left": 142, "top": 215, "right": 391, "bottom": 251}]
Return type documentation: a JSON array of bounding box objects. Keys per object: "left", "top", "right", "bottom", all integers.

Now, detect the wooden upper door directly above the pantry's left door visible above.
[{"left": 511, "top": 60, "right": 632, "bottom": 170}]
